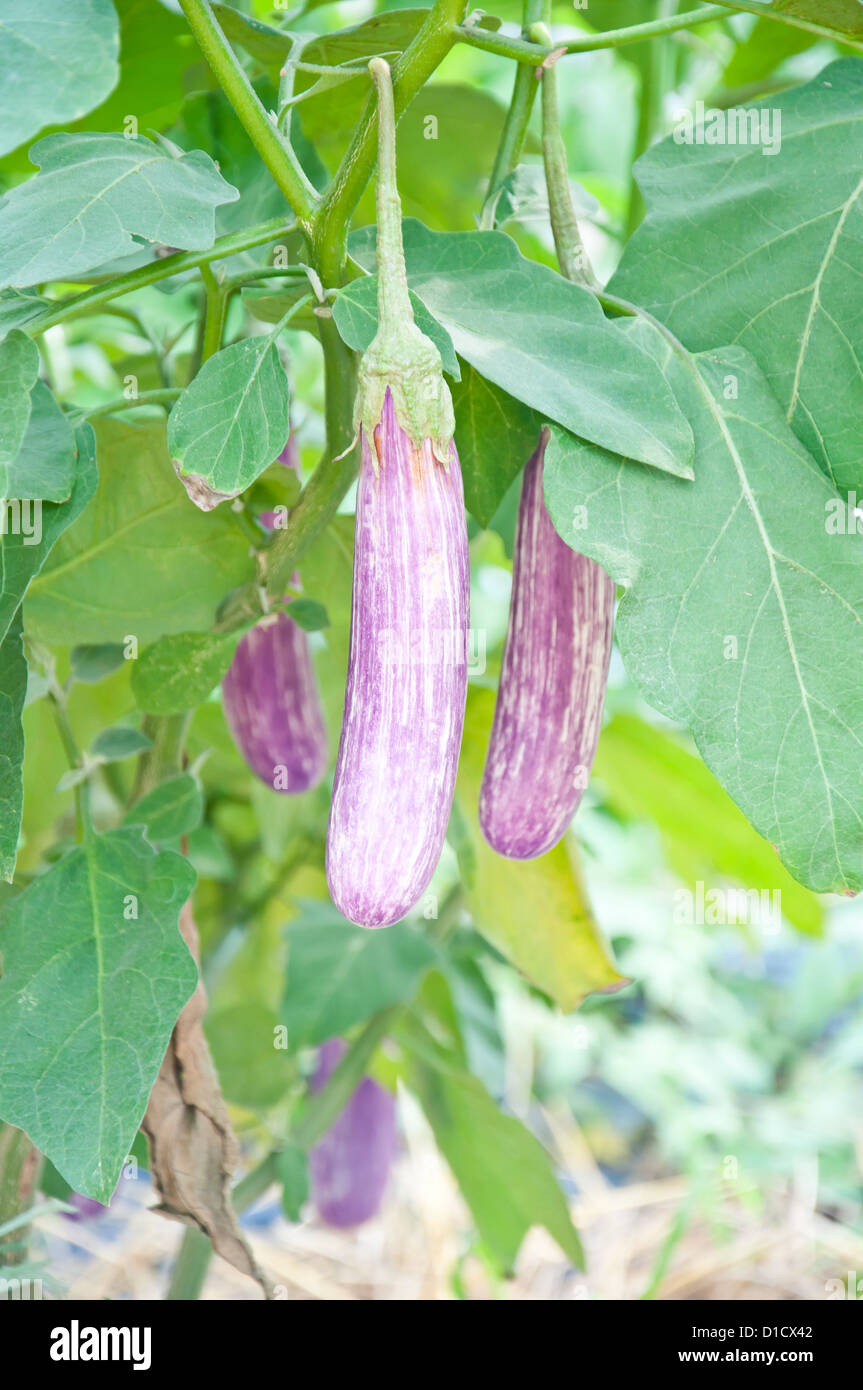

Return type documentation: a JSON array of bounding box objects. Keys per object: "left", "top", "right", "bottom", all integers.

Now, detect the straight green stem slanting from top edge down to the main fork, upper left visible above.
[{"left": 179, "top": 0, "right": 318, "bottom": 236}]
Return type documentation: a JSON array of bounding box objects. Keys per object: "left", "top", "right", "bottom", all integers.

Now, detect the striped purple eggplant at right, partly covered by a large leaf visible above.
[{"left": 479, "top": 435, "right": 616, "bottom": 859}]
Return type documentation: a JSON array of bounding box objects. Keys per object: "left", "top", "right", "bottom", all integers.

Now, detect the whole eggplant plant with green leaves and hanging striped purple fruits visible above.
[{"left": 0, "top": 0, "right": 863, "bottom": 1300}]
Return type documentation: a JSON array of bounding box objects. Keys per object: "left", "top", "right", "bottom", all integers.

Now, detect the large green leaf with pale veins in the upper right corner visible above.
[{"left": 609, "top": 58, "right": 863, "bottom": 493}]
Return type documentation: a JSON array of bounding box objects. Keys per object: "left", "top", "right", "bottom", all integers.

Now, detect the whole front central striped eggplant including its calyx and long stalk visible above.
[{"left": 327, "top": 58, "right": 470, "bottom": 927}]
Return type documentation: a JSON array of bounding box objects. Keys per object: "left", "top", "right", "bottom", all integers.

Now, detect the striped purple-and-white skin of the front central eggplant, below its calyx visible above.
[{"left": 327, "top": 389, "right": 470, "bottom": 927}]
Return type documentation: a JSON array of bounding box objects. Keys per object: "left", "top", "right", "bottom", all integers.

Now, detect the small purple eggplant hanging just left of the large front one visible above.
[{"left": 222, "top": 613, "right": 328, "bottom": 792}]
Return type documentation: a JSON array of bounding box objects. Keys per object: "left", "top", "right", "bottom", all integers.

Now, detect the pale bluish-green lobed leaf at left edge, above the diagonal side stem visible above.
[{"left": 0, "top": 133, "right": 239, "bottom": 285}]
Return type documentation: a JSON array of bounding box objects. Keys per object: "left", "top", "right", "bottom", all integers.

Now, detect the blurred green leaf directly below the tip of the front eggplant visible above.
[{"left": 281, "top": 902, "right": 436, "bottom": 1052}]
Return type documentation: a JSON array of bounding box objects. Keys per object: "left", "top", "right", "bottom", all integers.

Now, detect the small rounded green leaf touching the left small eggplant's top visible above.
[{"left": 132, "top": 632, "right": 243, "bottom": 714}]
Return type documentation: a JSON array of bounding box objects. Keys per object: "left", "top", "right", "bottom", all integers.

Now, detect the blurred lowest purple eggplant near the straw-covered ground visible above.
[{"left": 309, "top": 1038, "right": 396, "bottom": 1226}]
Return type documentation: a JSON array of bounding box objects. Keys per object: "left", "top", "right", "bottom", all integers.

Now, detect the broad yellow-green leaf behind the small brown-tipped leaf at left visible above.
[{"left": 26, "top": 420, "right": 253, "bottom": 646}]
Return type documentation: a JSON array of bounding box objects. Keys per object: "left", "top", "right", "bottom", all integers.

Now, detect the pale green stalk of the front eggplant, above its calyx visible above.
[{"left": 368, "top": 58, "right": 414, "bottom": 329}]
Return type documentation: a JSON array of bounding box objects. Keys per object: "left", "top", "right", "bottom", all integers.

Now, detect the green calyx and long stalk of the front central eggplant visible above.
[{"left": 356, "top": 58, "right": 456, "bottom": 466}]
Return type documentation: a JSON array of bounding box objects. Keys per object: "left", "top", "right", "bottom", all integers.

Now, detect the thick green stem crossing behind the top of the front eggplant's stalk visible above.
[{"left": 305, "top": 0, "right": 466, "bottom": 288}]
